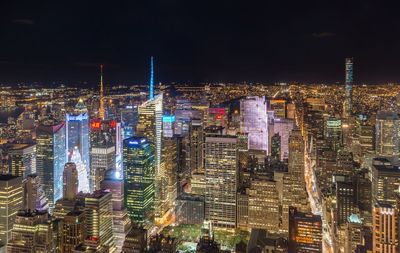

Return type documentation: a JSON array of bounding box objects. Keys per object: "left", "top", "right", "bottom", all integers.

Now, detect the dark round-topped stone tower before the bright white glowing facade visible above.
[{"left": 63, "top": 162, "right": 78, "bottom": 200}]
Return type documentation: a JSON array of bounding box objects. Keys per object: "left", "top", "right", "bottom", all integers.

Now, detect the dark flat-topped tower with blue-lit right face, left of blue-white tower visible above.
[{"left": 36, "top": 122, "right": 67, "bottom": 212}]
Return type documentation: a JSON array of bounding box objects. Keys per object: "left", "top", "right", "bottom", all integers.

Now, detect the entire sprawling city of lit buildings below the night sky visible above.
[{"left": 0, "top": 58, "right": 400, "bottom": 253}]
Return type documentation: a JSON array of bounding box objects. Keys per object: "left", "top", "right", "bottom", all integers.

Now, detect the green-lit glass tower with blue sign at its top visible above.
[{"left": 123, "top": 137, "right": 156, "bottom": 224}]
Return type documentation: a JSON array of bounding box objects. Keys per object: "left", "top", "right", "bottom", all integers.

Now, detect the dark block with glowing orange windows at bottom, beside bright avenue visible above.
[{"left": 289, "top": 207, "right": 322, "bottom": 253}]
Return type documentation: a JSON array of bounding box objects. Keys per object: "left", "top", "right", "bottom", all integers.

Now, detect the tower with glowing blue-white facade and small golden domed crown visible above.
[{"left": 66, "top": 99, "right": 90, "bottom": 192}]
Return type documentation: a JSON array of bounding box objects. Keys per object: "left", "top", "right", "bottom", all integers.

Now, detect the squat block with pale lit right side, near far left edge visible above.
[{"left": 8, "top": 144, "right": 36, "bottom": 179}]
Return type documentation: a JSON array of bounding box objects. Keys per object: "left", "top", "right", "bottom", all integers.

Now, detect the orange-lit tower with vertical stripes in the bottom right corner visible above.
[{"left": 372, "top": 203, "right": 399, "bottom": 253}]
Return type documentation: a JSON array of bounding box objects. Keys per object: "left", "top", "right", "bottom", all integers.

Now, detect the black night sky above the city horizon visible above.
[{"left": 0, "top": 0, "right": 400, "bottom": 84}]
